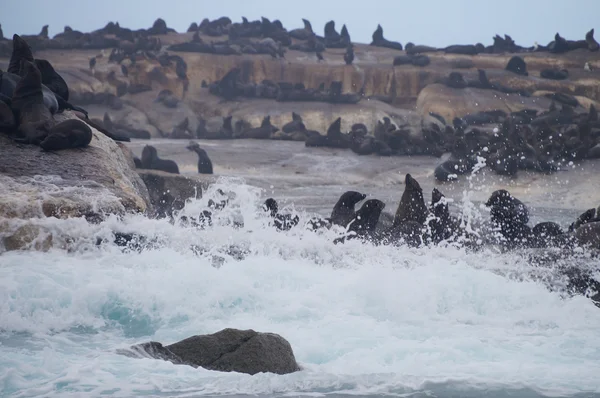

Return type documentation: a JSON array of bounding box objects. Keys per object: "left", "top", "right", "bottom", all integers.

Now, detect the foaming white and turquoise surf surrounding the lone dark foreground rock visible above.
[{"left": 0, "top": 141, "right": 600, "bottom": 397}]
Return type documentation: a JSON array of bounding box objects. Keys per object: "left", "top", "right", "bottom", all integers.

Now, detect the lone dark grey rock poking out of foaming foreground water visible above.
[{"left": 118, "top": 329, "right": 300, "bottom": 375}]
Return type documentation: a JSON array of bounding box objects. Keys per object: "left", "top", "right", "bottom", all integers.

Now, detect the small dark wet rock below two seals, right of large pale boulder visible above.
[{"left": 138, "top": 169, "right": 202, "bottom": 218}]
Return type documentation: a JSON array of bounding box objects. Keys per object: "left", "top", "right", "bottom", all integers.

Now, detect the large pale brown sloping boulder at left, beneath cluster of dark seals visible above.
[{"left": 0, "top": 112, "right": 151, "bottom": 219}]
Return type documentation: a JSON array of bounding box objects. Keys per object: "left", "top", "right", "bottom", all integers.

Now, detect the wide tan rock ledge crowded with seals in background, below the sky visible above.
[{"left": 0, "top": 17, "right": 600, "bottom": 180}]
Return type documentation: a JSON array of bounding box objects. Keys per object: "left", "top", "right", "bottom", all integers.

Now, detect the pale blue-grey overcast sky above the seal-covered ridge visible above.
[{"left": 0, "top": 0, "right": 600, "bottom": 47}]
